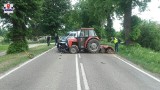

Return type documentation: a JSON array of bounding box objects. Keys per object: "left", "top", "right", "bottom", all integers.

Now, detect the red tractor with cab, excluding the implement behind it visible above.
[{"left": 68, "top": 28, "right": 100, "bottom": 53}]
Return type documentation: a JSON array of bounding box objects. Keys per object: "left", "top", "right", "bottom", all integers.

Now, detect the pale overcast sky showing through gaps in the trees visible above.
[{"left": 71, "top": 0, "right": 160, "bottom": 31}]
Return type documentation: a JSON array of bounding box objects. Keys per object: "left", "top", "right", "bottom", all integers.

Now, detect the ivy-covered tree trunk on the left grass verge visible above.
[{"left": 7, "top": 12, "right": 28, "bottom": 54}]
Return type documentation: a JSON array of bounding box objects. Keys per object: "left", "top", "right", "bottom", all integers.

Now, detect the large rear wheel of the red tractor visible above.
[{"left": 87, "top": 39, "right": 100, "bottom": 53}]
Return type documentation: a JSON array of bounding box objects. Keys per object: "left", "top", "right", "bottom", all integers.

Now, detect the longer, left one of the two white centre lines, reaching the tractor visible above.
[{"left": 75, "top": 54, "right": 81, "bottom": 90}]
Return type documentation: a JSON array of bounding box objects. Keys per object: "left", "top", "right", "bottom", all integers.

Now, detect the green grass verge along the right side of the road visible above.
[{"left": 118, "top": 45, "right": 160, "bottom": 74}]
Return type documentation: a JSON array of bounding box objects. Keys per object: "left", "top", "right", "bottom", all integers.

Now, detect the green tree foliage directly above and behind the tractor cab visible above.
[{"left": 64, "top": 0, "right": 104, "bottom": 36}]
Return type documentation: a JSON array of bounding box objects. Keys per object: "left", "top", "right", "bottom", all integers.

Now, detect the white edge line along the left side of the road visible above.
[{"left": 0, "top": 47, "right": 55, "bottom": 80}]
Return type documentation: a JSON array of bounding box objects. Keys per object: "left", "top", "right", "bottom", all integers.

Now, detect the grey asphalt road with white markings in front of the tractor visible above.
[{"left": 0, "top": 48, "right": 160, "bottom": 90}]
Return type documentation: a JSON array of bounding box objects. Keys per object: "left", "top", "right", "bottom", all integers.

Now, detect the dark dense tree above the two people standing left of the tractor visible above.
[{"left": 41, "top": 0, "right": 70, "bottom": 35}]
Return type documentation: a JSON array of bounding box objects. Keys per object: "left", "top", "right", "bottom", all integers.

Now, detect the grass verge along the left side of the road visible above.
[{"left": 0, "top": 45, "right": 53, "bottom": 73}]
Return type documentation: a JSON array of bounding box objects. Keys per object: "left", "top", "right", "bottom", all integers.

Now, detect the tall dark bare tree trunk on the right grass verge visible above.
[{"left": 123, "top": 0, "right": 132, "bottom": 45}]
